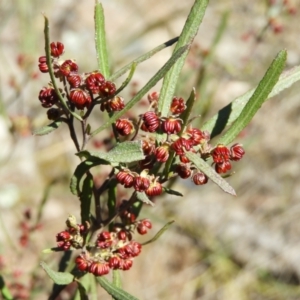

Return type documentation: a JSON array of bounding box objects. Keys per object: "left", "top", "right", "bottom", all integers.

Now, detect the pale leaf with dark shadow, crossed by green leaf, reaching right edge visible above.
[{"left": 201, "top": 54, "right": 300, "bottom": 137}]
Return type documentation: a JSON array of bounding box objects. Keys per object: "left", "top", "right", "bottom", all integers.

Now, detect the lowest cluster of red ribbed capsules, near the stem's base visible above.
[{"left": 56, "top": 210, "right": 152, "bottom": 276}]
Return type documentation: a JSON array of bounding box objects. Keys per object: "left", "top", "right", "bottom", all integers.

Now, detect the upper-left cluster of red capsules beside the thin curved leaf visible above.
[{"left": 39, "top": 42, "right": 118, "bottom": 120}]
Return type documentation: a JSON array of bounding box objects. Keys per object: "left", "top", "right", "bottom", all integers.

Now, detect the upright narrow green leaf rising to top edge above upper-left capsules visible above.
[{"left": 94, "top": 1, "right": 109, "bottom": 78}]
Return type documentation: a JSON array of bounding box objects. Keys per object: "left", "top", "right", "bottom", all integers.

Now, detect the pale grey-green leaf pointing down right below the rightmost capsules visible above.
[{"left": 185, "top": 152, "right": 236, "bottom": 196}]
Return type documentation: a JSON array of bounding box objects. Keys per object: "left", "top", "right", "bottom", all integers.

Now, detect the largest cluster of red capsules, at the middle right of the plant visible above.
[{"left": 116, "top": 92, "right": 245, "bottom": 192}]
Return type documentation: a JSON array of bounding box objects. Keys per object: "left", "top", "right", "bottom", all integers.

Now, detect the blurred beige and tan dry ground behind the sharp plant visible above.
[{"left": 0, "top": 0, "right": 300, "bottom": 300}]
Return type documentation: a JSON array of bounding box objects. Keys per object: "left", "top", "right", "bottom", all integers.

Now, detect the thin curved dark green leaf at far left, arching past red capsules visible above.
[{"left": 44, "top": 16, "right": 82, "bottom": 121}]
